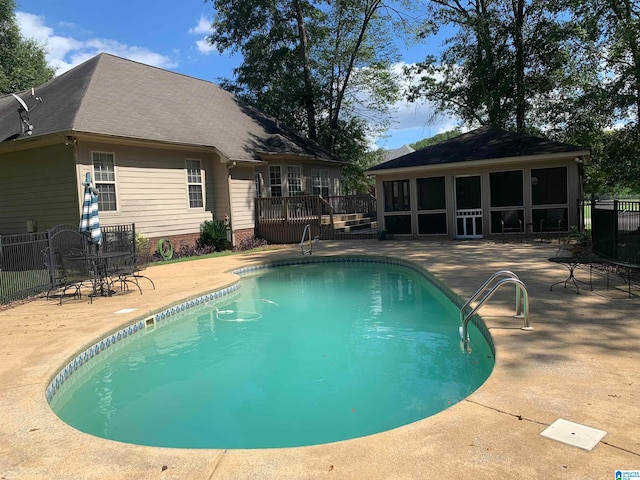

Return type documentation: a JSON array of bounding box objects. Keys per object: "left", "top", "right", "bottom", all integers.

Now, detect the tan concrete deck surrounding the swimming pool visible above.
[{"left": 0, "top": 240, "right": 640, "bottom": 480}]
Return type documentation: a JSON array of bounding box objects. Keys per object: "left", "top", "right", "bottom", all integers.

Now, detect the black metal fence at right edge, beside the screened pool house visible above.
[{"left": 590, "top": 199, "right": 640, "bottom": 265}]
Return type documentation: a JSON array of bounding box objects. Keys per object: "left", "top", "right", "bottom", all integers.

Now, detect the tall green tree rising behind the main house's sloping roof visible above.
[{"left": 209, "top": 0, "right": 408, "bottom": 160}]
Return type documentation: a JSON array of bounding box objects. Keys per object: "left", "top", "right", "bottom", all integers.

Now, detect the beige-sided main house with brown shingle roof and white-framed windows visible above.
[{"left": 0, "top": 53, "right": 343, "bottom": 244}]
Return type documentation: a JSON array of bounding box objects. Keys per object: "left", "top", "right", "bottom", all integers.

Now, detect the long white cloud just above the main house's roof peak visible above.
[{"left": 16, "top": 12, "right": 177, "bottom": 75}]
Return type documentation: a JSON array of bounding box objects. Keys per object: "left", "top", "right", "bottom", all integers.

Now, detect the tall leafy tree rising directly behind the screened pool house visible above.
[{"left": 408, "top": 0, "right": 586, "bottom": 132}]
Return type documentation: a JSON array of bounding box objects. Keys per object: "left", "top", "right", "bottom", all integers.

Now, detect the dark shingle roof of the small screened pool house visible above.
[{"left": 368, "top": 127, "right": 587, "bottom": 171}]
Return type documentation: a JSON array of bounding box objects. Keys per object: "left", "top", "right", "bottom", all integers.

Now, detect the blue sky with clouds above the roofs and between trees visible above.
[{"left": 16, "top": 0, "right": 455, "bottom": 149}]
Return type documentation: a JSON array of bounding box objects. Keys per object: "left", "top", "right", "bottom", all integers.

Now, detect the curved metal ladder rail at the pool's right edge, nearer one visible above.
[{"left": 460, "top": 270, "right": 533, "bottom": 350}]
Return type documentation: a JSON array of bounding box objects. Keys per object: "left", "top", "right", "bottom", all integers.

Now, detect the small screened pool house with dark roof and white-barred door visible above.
[{"left": 366, "top": 127, "right": 590, "bottom": 239}]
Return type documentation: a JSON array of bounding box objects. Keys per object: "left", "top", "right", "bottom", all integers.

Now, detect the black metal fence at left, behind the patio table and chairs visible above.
[{"left": 0, "top": 224, "right": 135, "bottom": 304}]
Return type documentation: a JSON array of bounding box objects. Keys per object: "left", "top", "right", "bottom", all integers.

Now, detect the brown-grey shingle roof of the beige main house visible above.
[{"left": 0, "top": 53, "right": 341, "bottom": 162}]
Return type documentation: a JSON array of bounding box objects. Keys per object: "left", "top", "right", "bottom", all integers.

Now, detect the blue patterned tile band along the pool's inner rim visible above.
[{"left": 45, "top": 255, "right": 495, "bottom": 404}]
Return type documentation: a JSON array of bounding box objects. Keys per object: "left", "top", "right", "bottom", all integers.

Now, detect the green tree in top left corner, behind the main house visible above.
[{"left": 0, "top": 0, "right": 55, "bottom": 94}]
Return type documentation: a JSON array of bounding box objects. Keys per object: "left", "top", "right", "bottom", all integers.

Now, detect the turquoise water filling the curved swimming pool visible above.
[{"left": 51, "top": 263, "right": 494, "bottom": 448}]
